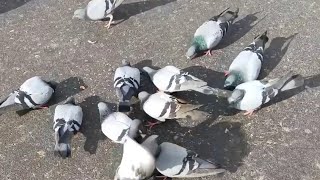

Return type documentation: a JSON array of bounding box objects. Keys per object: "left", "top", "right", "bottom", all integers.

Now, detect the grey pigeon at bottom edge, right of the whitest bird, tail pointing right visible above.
[{"left": 156, "top": 142, "right": 225, "bottom": 178}]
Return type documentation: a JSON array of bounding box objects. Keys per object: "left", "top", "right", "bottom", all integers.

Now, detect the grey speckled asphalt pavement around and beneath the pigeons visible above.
[{"left": 0, "top": 0, "right": 320, "bottom": 180}]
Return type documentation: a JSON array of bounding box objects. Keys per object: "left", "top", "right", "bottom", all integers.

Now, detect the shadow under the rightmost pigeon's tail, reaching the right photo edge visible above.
[{"left": 262, "top": 74, "right": 320, "bottom": 108}]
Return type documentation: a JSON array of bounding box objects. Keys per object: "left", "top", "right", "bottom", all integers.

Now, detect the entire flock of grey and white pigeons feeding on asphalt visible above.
[{"left": 0, "top": 0, "right": 304, "bottom": 180}]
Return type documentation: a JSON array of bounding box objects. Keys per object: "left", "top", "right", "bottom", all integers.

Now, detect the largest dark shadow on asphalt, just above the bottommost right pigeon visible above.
[{"left": 149, "top": 115, "right": 250, "bottom": 172}]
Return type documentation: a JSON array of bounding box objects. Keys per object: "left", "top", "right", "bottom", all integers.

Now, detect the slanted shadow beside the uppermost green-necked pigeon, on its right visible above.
[{"left": 215, "top": 11, "right": 265, "bottom": 50}]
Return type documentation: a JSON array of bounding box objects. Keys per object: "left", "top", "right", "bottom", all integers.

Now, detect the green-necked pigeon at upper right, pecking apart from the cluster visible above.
[{"left": 186, "top": 8, "right": 239, "bottom": 59}]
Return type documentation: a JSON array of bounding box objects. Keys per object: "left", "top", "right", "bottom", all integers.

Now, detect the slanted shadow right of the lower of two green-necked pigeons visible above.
[{"left": 259, "top": 33, "right": 298, "bottom": 79}]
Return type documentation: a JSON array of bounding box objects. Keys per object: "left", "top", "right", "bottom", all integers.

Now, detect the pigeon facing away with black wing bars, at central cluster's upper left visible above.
[{"left": 113, "top": 60, "right": 140, "bottom": 112}]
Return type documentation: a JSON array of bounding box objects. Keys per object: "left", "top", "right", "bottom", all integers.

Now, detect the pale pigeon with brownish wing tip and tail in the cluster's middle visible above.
[{"left": 138, "top": 91, "right": 202, "bottom": 127}]
